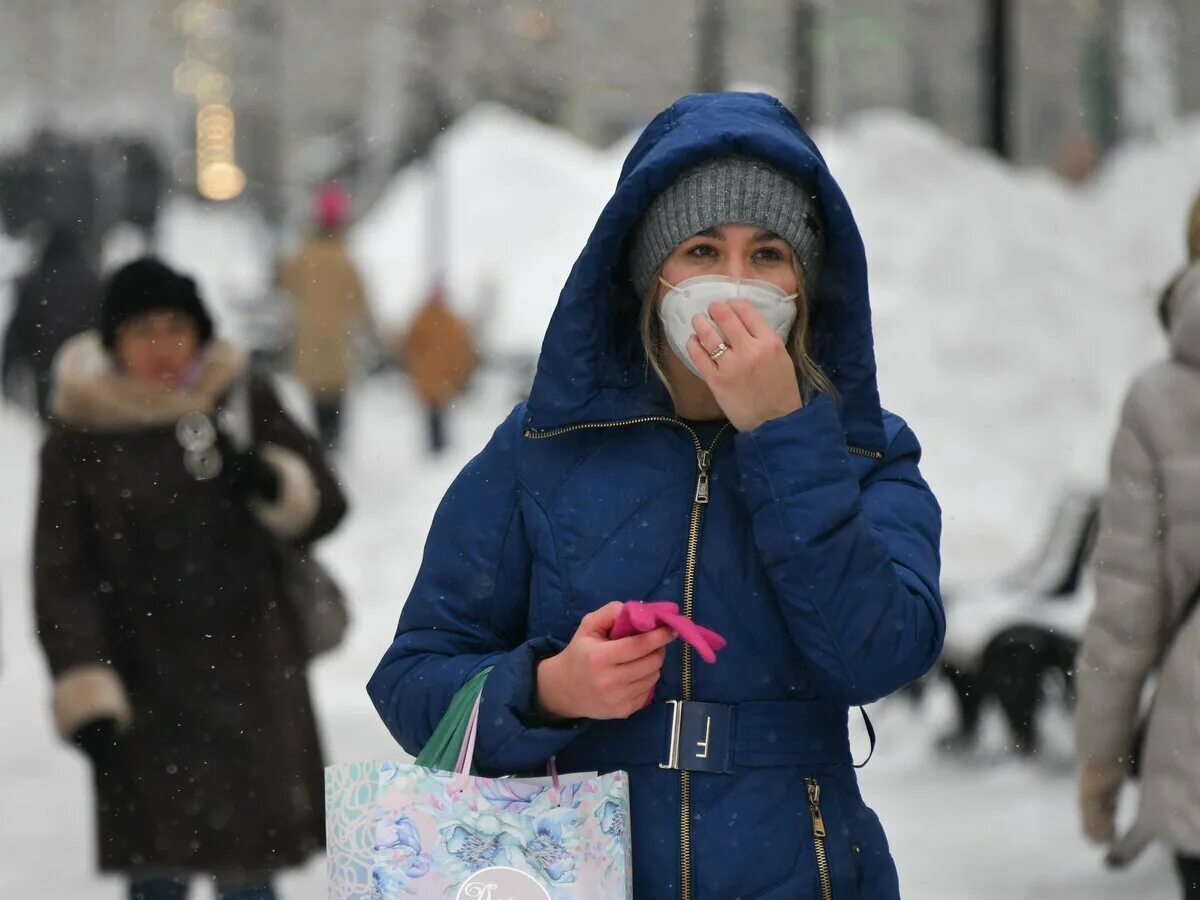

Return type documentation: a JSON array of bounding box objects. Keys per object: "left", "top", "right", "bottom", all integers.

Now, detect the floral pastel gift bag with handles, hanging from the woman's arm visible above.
[{"left": 325, "top": 673, "right": 632, "bottom": 900}]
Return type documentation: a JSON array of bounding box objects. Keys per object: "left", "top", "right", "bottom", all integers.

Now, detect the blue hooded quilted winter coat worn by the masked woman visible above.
[{"left": 368, "top": 94, "right": 944, "bottom": 900}]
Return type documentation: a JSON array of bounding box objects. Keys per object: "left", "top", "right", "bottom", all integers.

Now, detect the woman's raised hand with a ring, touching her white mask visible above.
[{"left": 688, "top": 300, "right": 804, "bottom": 431}]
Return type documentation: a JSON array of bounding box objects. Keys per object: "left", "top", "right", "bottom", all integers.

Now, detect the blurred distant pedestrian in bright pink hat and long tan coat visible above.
[{"left": 280, "top": 184, "right": 371, "bottom": 450}]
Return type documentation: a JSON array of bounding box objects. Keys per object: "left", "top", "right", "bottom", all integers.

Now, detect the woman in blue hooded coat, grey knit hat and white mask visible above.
[{"left": 368, "top": 94, "right": 944, "bottom": 900}]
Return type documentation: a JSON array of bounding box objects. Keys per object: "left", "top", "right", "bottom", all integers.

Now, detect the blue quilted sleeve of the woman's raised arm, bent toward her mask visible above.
[{"left": 737, "top": 396, "right": 946, "bottom": 706}]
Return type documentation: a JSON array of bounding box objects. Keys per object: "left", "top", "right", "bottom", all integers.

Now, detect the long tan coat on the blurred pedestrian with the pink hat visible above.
[{"left": 280, "top": 238, "right": 368, "bottom": 394}]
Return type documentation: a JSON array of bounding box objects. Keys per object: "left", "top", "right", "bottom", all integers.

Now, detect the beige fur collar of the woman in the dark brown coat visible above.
[{"left": 50, "top": 331, "right": 246, "bottom": 431}]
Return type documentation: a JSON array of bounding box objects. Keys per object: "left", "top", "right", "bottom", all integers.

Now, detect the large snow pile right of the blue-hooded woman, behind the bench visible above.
[{"left": 818, "top": 113, "right": 1171, "bottom": 578}]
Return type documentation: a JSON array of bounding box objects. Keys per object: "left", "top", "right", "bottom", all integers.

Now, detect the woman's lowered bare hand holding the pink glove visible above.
[{"left": 538, "top": 600, "right": 676, "bottom": 719}]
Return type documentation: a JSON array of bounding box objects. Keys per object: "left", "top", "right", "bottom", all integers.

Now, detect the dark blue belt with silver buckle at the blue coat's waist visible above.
[{"left": 558, "top": 700, "right": 875, "bottom": 774}]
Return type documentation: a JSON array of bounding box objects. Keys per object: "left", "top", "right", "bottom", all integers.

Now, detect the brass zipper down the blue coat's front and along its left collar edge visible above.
[{"left": 524, "top": 415, "right": 730, "bottom": 900}]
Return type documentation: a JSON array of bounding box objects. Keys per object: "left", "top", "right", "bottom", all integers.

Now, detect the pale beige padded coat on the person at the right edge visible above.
[{"left": 1078, "top": 265, "right": 1200, "bottom": 859}]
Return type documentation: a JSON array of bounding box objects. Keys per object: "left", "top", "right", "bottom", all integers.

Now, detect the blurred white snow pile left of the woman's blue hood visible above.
[{"left": 352, "top": 104, "right": 617, "bottom": 352}]
